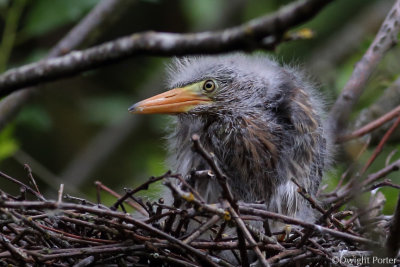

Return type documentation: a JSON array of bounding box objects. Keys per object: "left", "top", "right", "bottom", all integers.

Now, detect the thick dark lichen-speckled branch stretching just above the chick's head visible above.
[{"left": 0, "top": 0, "right": 331, "bottom": 96}]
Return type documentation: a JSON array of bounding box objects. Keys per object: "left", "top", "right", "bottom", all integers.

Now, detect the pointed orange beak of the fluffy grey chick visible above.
[{"left": 128, "top": 84, "right": 211, "bottom": 114}]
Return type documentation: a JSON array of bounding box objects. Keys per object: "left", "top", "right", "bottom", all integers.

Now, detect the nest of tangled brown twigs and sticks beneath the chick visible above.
[{"left": 0, "top": 137, "right": 400, "bottom": 266}]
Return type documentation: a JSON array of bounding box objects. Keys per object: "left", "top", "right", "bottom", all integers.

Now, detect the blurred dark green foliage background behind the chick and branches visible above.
[{"left": 0, "top": 0, "right": 400, "bottom": 212}]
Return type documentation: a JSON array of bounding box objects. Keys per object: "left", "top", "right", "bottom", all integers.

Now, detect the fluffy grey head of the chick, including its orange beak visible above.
[{"left": 129, "top": 54, "right": 284, "bottom": 119}]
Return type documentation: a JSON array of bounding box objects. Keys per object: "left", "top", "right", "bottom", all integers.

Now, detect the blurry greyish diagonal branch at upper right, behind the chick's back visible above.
[{"left": 329, "top": 0, "right": 400, "bottom": 137}]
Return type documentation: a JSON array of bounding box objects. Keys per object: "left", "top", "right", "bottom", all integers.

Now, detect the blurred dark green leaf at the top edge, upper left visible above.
[{"left": 22, "top": 0, "right": 100, "bottom": 37}]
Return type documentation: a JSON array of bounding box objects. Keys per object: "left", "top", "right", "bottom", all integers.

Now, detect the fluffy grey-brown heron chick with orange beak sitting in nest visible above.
[{"left": 129, "top": 54, "right": 329, "bottom": 224}]
